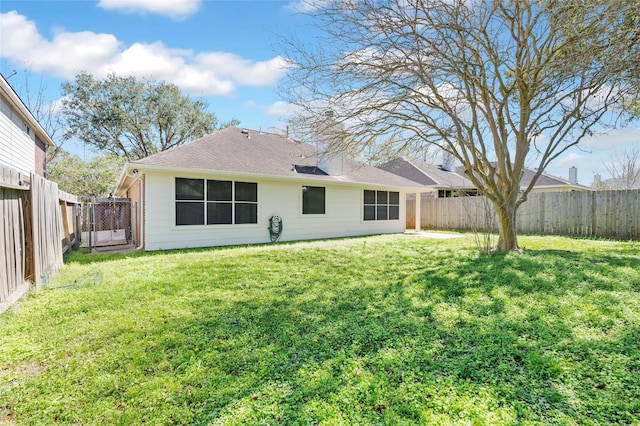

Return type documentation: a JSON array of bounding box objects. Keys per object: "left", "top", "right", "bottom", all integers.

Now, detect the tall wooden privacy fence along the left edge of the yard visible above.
[{"left": 0, "top": 164, "right": 80, "bottom": 305}]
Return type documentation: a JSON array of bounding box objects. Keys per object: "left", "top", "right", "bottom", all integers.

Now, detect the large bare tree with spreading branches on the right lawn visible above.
[{"left": 282, "top": 0, "right": 640, "bottom": 251}]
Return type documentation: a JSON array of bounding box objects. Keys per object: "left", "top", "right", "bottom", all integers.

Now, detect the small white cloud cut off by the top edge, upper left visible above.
[{"left": 98, "top": 0, "right": 202, "bottom": 19}]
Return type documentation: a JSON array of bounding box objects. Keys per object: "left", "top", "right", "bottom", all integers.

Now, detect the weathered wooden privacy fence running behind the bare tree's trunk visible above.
[{"left": 407, "top": 190, "right": 640, "bottom": 239}]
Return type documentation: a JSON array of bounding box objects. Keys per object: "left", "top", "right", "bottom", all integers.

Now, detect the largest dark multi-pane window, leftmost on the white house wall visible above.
[{"left": 176, "top": 178, "right": 258, "bottom": 225}]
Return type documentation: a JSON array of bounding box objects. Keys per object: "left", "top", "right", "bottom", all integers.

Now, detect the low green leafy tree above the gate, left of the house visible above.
[{"left": 48, "top": 150, "right": 124, "bottom": 200}]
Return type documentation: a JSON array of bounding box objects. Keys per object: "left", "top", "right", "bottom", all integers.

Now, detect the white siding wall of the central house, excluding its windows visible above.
[{"left": 144, "top": 169, "right": 406, "bottom": 250}]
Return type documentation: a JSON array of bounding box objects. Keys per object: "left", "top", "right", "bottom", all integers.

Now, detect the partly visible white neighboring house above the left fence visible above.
[{"left": 0, "top": 76, "right": 53, "bottom": 180}]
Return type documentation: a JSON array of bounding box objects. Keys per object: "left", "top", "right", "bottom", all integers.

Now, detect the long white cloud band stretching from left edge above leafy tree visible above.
[{"left": 0, "top": 11, "right": 287, "bottom": 96}]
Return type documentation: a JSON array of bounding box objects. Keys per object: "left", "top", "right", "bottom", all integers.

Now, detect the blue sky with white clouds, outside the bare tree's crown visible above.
[{"left": 0, "top": 0, "right": 640, "bottom": 185}]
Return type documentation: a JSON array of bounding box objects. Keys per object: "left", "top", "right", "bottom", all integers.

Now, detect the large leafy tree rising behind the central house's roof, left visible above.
[{"left": 62, "top": 73, "right": 239, "bottom": 161}]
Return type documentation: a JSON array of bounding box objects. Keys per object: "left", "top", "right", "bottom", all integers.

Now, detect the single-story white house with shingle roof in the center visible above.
[{"left": 115, "top": 127, "right": 423, "bottom": 250}]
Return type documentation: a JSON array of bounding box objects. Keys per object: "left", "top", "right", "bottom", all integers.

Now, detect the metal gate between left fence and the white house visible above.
[{"left": 82, "top": 198, "right": 138, "bottom": 251}]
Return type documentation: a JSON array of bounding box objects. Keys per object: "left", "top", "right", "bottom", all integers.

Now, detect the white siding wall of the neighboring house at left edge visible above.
[{"left": 0, "top": 100, "right": 36, "bottom": 174}]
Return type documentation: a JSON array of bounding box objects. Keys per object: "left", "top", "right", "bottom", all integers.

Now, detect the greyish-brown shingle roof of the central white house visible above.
[{"left": 119, "top": 127, "right": 420, "bottom": 190}]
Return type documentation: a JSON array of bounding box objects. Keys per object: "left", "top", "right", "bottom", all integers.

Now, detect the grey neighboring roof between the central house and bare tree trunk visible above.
[{"left": 379, "top": 157, "right": 475, "bottom": 189}]
